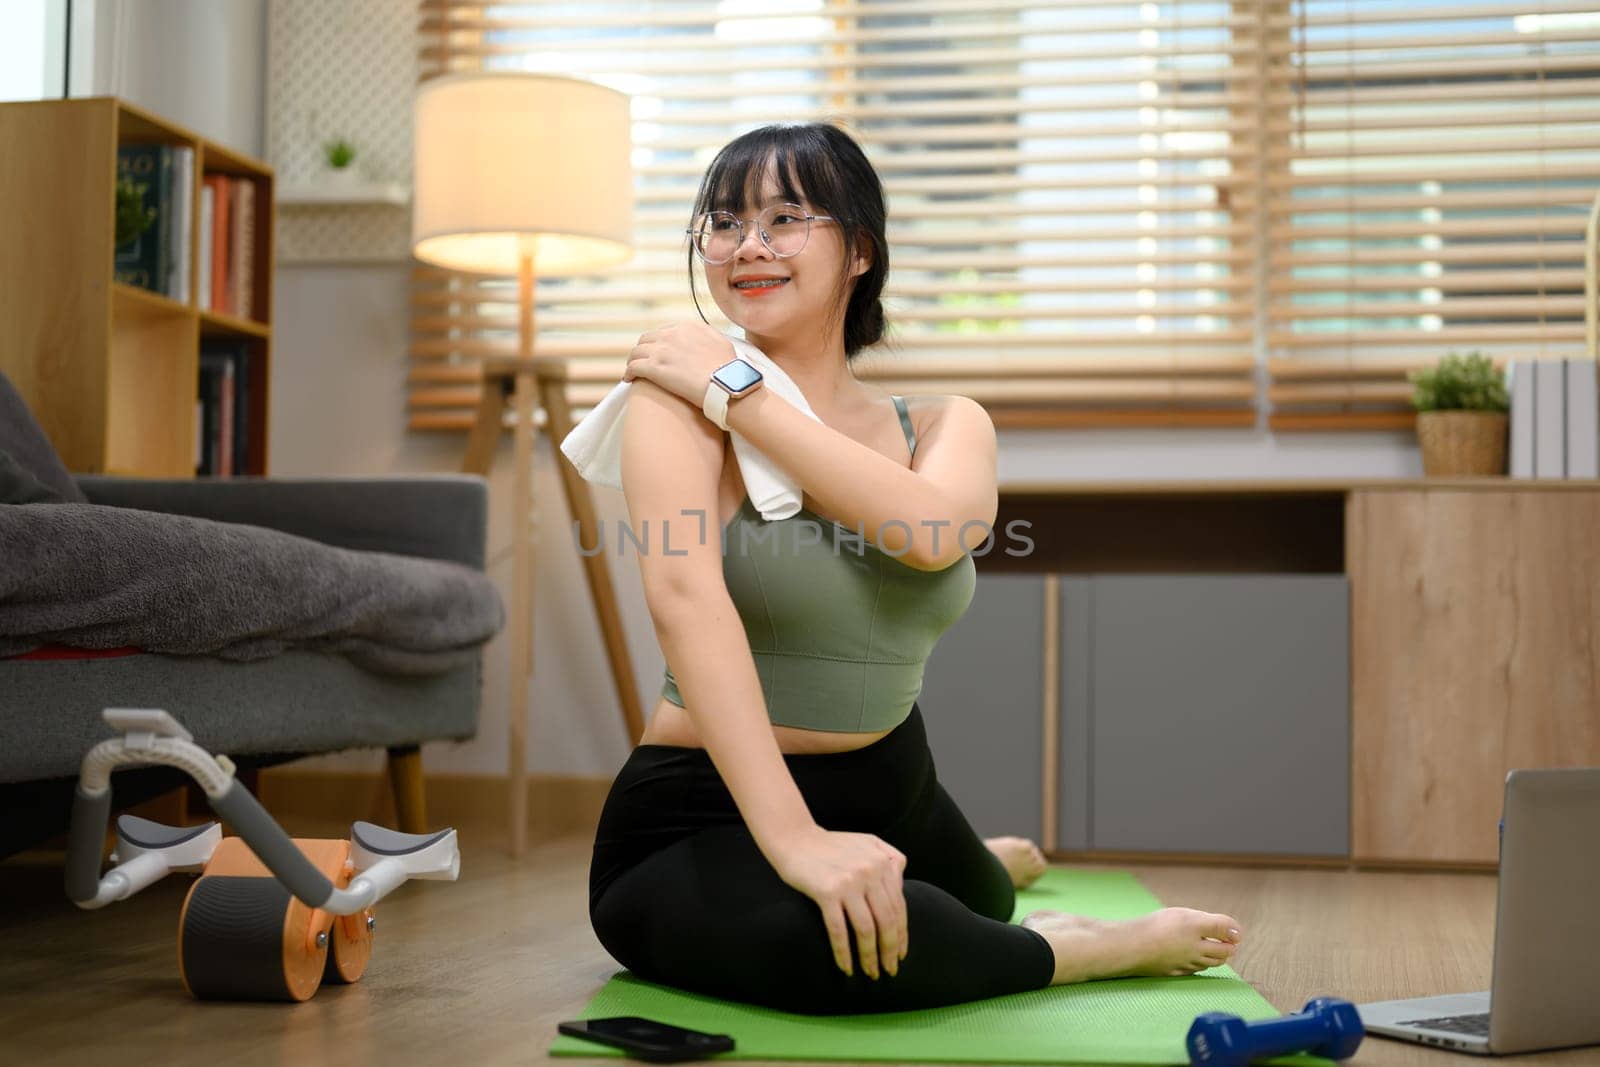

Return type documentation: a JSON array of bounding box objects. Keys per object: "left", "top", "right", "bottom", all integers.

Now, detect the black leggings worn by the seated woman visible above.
[{"left": 589, "top": 704, "right": 1054, "bottom": 1014}]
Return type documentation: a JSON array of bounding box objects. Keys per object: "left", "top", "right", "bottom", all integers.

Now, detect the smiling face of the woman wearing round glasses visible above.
[{"left": 704, "top": 174, "right": 867, "bottom": 338}]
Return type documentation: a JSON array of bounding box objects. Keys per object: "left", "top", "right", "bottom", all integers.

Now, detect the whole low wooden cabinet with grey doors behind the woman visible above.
[{"left": 922, "top": 478, "right": 1600, "bottom": 867}]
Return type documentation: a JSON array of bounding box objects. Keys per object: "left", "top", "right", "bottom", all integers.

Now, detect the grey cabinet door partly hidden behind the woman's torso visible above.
[{"left": 917, "top": 574, "right": 1045, "bottom": 841}]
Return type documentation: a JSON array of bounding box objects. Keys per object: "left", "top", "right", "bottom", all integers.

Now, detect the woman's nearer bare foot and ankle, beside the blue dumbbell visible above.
[{"left": 1022, "top": 907, "right": 1242, "bottom": 985}]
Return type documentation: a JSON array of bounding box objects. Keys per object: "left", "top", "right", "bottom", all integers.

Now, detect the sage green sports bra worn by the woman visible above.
[{"left": 661, "top": 397, "right": 978, "bottom": 733}]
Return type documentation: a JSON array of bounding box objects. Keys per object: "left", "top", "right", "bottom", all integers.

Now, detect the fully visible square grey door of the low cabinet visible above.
[{"left": 1062, "top": 574, "right": 1350, "bottom": 856}]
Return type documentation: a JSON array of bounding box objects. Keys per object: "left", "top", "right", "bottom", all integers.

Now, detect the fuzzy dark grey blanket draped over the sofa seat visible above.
[{"left": 0, "top": 504, "right": 504, "bottom": 673}]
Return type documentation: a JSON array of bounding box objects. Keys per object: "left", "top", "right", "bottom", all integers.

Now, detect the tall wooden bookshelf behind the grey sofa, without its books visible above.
[{"left": 0, "top": 96, "right": 274, "bottom": 478}]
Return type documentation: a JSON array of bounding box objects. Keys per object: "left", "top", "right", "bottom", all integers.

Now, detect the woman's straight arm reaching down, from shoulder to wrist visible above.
[{"left": 622, "top": 379, "right": 814, "bottom": 861}]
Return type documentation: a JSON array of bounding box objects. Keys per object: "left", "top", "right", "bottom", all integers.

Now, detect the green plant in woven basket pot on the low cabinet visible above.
[{"left": 1408, "top": 352, "right": 1510, "bottom": 478}]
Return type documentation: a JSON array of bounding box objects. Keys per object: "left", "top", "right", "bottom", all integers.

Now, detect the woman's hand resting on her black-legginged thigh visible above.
[{"left": 773, "top": 825, "right": 909, "bottom": 979}]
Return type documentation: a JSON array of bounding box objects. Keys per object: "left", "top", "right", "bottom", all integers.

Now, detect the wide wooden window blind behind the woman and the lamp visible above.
[{"left": 410, "top": 0, "right": 1270, "bottom": 429}]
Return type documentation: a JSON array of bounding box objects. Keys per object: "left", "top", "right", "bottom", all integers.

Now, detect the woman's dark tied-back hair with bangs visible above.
[{"left": 688, "top": 122, "right": 890, "bottom": 360}]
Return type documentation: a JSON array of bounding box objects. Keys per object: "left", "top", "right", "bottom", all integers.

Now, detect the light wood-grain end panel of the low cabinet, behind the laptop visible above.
[{"left": 1349, "top": 488, "right": 1600, "bottom": 864}]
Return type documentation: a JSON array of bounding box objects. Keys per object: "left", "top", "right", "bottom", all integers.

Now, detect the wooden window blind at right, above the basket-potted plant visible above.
[{"left": 1264, "top": 0, "right": 1600, "bottom": 429}]
